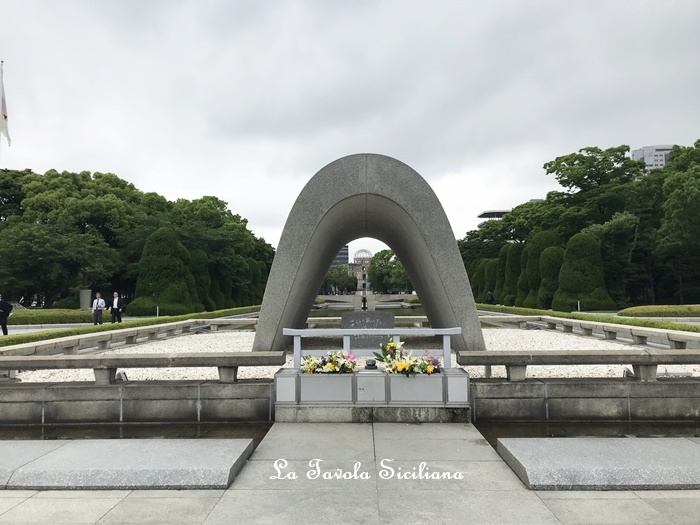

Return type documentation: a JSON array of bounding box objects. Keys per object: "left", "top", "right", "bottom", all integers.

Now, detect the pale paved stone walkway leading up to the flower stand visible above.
[{"left": 0, "top": 423, "right": 700, "bottom": 525}]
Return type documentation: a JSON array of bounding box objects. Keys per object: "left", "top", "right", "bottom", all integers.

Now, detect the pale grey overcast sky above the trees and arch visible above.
[{"left": 0, "top": 0, "right": 700, "bottom": 254}]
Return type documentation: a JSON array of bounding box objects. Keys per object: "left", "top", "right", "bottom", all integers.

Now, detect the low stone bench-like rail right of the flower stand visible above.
[{"left": 457, "top": 348, "right": 700, "bottom": 381}]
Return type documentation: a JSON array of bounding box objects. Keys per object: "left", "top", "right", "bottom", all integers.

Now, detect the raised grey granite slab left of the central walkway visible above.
[{"left": 0, "top": 439, "right": 253, "bottom": 490}]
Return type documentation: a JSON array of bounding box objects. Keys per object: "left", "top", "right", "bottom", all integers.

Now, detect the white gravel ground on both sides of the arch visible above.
[{"left": 17, "top": 328, "right": 700, "bottom": 383}]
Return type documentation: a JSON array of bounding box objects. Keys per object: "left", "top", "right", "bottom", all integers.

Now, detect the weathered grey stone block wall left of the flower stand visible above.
[{"left": 0, "top": 379, "right": 274, "bottom": 424}]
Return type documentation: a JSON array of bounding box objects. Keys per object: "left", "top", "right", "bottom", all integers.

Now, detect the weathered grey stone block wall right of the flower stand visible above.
[{"left": 470, "top": 377, "right": 700, "bottom": 422}]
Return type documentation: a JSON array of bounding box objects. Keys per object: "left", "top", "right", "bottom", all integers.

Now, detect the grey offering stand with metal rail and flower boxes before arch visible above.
[{"left": 275, "top": 328, "right": 470, "bottom": 422}]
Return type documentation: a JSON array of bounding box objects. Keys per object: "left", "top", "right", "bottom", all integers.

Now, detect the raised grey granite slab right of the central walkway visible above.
[{"left": 497, "top": 438, "right": 700, "bottom": 490}]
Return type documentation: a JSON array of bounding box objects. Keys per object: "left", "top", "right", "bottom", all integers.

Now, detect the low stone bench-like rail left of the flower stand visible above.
[{"left": 0, "top": 352, "right": 286, "bottom": 385}]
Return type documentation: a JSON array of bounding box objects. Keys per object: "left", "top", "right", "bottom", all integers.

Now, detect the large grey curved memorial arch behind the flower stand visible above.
[{"left": 253, "top": 154, "right": 485, "bottom": 351}]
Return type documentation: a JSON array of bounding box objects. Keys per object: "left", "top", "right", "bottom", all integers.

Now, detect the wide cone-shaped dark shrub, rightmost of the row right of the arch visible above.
[{"left": 552, "top": 233, "right": 617, "bottom": 312}]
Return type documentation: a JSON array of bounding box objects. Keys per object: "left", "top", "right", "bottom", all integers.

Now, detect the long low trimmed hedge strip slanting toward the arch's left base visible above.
[{"left": 0, "top": 306, "right": 260, "bottom": 347}]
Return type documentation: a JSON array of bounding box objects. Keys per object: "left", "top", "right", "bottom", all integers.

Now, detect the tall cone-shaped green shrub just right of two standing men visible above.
[{"left": 128, "top": 227, "right": 204, "bottom": 315}]
